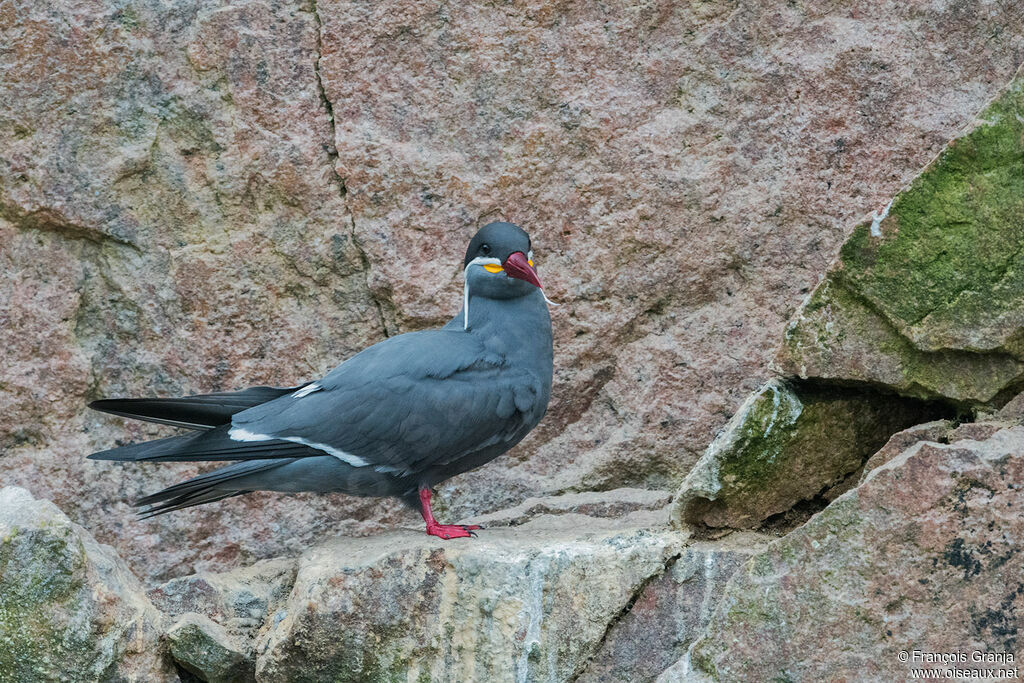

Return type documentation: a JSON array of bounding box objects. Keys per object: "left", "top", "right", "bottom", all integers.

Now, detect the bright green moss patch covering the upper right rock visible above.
[{"left": 841, "top": 80, "right": 1024, "bottom": 330}]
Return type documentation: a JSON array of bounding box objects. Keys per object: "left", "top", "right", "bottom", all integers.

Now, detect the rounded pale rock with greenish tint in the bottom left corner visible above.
[{"left": 0, "top": 486, "right": 176, "bottom": 683}]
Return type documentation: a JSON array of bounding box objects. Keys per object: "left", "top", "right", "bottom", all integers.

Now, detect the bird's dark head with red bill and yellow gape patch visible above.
[{"left": 464, "top": 223, "right": 541, "bottom": 299}]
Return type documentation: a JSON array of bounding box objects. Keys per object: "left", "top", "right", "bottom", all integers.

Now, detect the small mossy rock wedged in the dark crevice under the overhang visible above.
[{"left": 673, "top": 380, "right": 949, "bottom": 528}]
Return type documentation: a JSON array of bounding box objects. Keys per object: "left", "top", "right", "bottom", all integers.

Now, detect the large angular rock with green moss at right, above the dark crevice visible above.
[{"left": 778, "top": 77, "right": 1024, "bottom": 403}]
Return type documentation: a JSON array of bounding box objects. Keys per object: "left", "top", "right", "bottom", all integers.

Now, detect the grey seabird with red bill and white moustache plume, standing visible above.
[{"left": 89, "top": 223, "right": 552, "bottom": 539}]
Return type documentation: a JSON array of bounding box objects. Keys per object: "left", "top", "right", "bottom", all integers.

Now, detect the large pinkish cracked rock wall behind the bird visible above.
[{"left": 0, "top": 0, "right": 1024, "bottom": 585}]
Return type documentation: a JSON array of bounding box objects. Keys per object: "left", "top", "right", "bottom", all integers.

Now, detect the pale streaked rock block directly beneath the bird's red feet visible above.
[{"left": 257, "top": 517, "right": 685, "bottom": 681}]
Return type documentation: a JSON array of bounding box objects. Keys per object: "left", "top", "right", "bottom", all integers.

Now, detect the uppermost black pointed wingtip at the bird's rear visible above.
[{"left": 89, "top": 386, "right": 302, "bottom": 429}]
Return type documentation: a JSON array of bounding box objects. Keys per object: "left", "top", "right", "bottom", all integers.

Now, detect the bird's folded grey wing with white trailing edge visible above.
[{"left": 232, "top": 331, "right": 543, "bottom": 473}]
